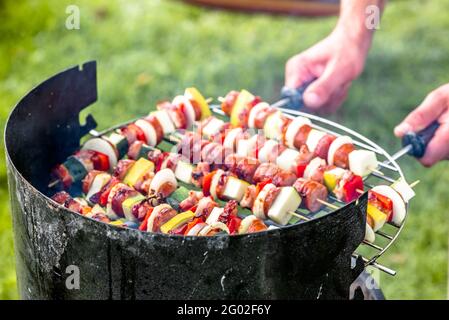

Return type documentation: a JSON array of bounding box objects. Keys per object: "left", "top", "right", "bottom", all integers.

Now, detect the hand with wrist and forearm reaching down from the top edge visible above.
[{"left": 285, "top": 0, "right": 385, "bottom": 112}]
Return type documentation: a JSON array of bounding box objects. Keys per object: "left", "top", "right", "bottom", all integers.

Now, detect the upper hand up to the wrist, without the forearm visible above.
[{"left": 285, "top": 29, "right": 369, "bottom": 112}]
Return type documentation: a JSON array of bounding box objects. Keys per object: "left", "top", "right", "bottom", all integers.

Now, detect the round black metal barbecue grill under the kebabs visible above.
[{"left": 5, "top": 62, "right": 408, "bottom": 299}]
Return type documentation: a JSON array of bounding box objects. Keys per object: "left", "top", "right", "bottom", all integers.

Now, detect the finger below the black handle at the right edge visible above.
[{"left": 419, "top": 123, "right": 449, "bottom": 167}]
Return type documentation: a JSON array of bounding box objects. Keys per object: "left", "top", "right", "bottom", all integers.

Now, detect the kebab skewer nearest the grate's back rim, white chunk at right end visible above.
[{"left": 217, "top": 90, "right": 383, "bottom": 176}]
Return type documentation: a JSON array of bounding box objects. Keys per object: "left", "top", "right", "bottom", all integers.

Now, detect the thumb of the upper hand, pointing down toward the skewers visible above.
[{"left": 304, "top": 60, "right": 351, "bottom": 109}]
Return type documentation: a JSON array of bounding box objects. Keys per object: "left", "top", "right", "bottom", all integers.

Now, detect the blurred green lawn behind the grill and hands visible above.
[{"left": 0, "top": 0, "right": 449, "bottom": 299}]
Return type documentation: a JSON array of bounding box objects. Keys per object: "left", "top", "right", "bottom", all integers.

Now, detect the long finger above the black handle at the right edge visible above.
[{"left": 394, "top": 87, "right": 448, "bottom": 138}]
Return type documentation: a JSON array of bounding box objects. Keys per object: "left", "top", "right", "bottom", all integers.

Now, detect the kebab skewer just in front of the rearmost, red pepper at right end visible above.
[{"left": 169, "top": 126, "right": 363, "bottom": 205}]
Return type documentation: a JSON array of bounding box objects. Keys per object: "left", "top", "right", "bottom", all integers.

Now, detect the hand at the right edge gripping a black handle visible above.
[{"left": 394, "top": 84, "right": 449, "bottom": 167}]
